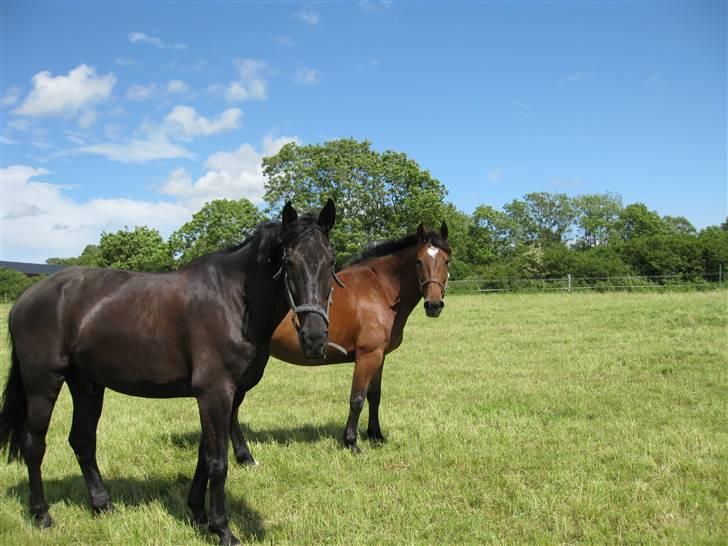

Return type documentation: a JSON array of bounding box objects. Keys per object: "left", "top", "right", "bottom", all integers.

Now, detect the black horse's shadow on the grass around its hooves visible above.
[{"left": 7, "top": 474, "right": 265, "bottom": 542}]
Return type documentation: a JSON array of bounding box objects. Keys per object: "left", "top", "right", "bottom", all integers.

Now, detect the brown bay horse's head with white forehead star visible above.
[{"left": 417, "top": 222, "right": 451, "bottom": 317}]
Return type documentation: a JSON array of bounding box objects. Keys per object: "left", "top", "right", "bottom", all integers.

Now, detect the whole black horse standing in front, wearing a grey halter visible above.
[{"left": 0, "top": 200, "right": 336, "bottom": 544}]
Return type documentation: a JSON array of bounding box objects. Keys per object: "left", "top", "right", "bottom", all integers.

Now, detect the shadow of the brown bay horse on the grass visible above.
[{"left": 165, "top": 421, "right": 344, "bottom": 448}]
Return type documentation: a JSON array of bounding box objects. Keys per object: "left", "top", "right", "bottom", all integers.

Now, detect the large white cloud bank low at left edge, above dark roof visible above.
[{"left": 0, "top": 165, "right": 193, "bottom": 263}]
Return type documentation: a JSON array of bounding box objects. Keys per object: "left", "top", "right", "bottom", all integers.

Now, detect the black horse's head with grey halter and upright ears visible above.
[{"left": 279, "top": 199, "right": 336, "bottom": 358}]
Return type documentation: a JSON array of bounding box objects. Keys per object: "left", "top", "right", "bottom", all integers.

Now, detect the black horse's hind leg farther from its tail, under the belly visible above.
[{"left": 67, "top": 377, "right": 114, "bottom": 512}]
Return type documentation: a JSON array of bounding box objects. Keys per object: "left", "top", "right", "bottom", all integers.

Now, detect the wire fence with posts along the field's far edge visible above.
[{"left": 448, "top": 271, "right": 726, "bottom": 293}]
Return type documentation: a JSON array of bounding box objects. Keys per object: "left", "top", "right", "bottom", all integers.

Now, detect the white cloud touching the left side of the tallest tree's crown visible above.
[{"left": 160, "top": 135, "right": 297, "bottom": 209}]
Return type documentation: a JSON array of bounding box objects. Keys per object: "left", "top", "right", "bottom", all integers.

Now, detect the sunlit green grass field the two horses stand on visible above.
[{"left": 0, "top": 291, "right": 728, "bottom": 546}]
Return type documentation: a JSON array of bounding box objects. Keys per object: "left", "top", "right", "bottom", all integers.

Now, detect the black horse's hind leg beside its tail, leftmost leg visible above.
[{"left": 22, "top": 372, "right": 63, "bottom": 527}]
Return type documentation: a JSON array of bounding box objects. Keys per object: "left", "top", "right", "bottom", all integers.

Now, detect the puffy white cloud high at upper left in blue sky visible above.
[{"left": 14, "top": 64, "right": 116, "bottom": 124}]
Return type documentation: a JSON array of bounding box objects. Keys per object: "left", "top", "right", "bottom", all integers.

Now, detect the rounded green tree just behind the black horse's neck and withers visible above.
[{"left": 169, "top": 199, "right": 263, "bottom": 265}]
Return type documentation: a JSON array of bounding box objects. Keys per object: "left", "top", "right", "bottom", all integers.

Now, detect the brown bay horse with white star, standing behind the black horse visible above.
[{"left": 230, "top": 222, "right": 451, "bottom": 456}]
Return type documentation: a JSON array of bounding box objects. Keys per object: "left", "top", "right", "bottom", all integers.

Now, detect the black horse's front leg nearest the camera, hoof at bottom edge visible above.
[{"left": 190, "top": 385, "right": 240, "bottom": 546}]
